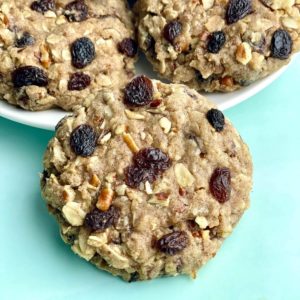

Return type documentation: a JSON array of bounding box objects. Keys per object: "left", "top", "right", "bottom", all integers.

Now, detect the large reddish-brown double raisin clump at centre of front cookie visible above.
[{"left": 125, "top": 147, "right": 171, "bottom": 188}]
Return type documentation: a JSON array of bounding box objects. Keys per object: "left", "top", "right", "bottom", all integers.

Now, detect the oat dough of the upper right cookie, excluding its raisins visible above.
[{"left": 135, "top": 0, "right": 300, "bottom": 92}]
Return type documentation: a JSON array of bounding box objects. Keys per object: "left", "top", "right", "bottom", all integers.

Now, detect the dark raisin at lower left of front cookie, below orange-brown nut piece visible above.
[{"left": 84, "top": 205, "right": 120, "bottom": 231}]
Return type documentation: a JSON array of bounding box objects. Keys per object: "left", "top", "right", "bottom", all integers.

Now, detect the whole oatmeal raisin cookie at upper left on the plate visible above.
[{"left": 0, "top": 0, "right": 136, "bottom": 110}]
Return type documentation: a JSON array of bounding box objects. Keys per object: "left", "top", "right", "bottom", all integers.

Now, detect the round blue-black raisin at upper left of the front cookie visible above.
[{"left": 70, "top": 124, "right": 97, "bottom": 157}]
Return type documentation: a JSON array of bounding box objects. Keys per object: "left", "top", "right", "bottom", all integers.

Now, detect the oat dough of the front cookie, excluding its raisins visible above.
[{"left": 41, "top": 80, "right": 252, "bottom": 281}]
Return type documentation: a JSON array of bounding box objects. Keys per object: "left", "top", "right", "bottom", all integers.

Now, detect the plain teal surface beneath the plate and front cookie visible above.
[{"left": 0, "top": 57, "right": 300, "bottom": 300}]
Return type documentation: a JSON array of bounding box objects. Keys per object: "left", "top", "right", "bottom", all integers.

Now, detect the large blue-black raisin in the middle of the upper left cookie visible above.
[{"left": 71, "top": 37, "right": 96, "bottom": 69}]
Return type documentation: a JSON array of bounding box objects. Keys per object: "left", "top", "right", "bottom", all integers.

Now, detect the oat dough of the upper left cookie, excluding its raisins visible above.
[{"left": 0, "top": 0, "right": 134, "bottom": 110}]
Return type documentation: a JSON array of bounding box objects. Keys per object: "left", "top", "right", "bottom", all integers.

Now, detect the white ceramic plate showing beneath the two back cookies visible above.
[{"left": 0, "top": 56, "right": 287, "bottom": 130}]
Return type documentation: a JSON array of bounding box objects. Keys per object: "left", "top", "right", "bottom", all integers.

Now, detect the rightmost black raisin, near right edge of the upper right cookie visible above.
[{"left": 271, "top": 29, "right": 293, "bottom": 59}]
